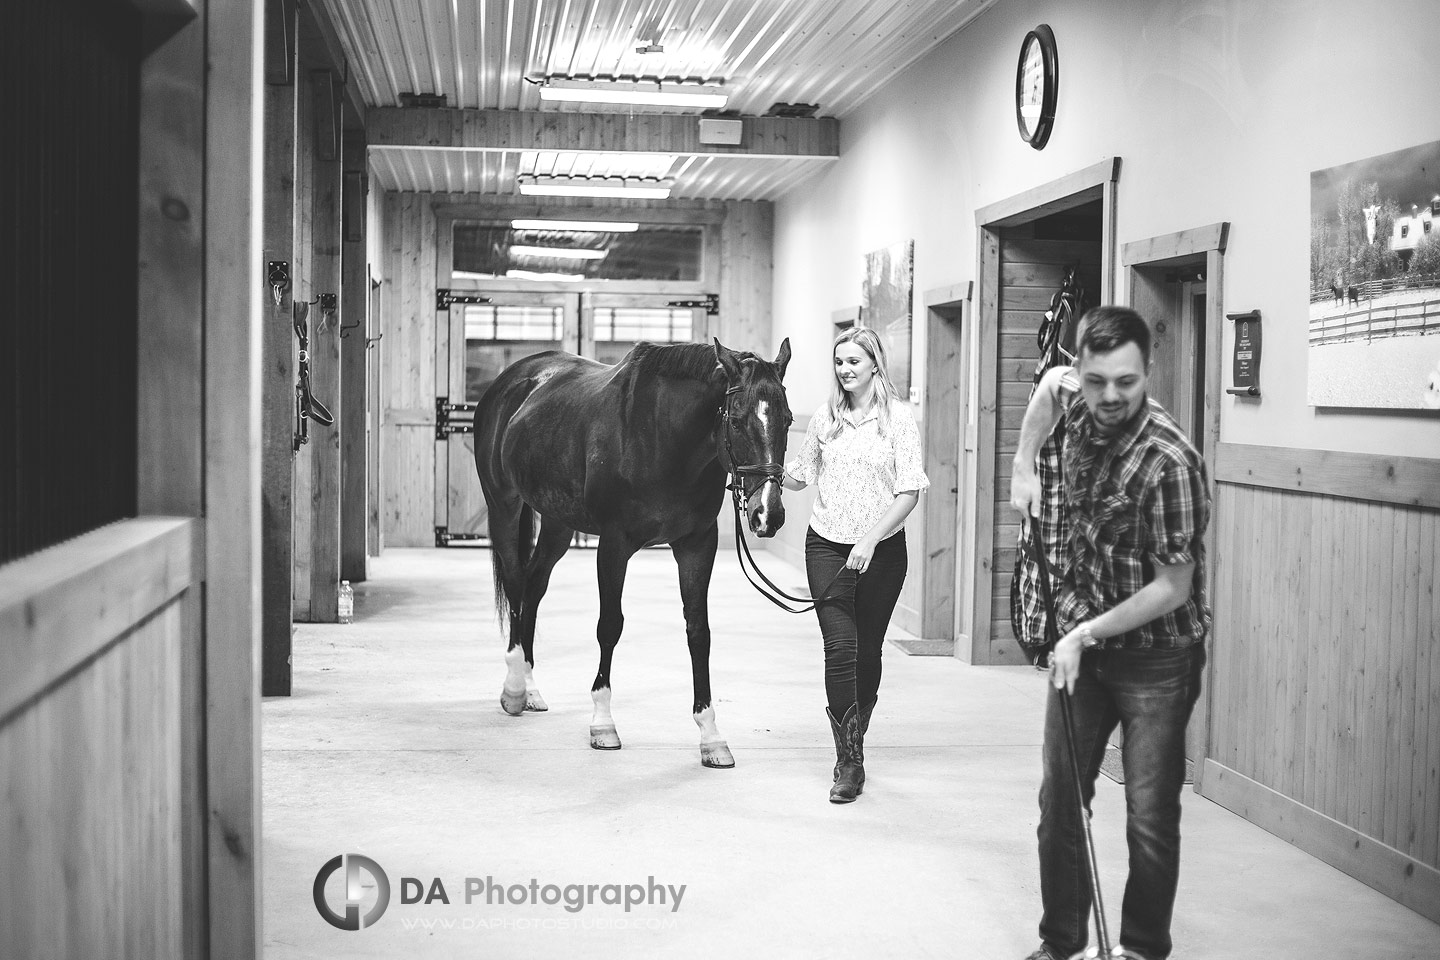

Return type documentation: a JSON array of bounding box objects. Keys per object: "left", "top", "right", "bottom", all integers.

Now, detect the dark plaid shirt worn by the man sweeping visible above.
[{"left": 1058, "top": 397, "right": 1211, "bottom": 648}]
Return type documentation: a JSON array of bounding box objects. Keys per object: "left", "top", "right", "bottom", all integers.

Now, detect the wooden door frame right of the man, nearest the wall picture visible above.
[{"left": 1120, "top": 220, "right": 1230, "bottom": 793}]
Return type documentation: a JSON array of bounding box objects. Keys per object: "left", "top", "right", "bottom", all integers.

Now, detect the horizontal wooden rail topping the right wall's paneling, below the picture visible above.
[{"left": 1215, "top": 443, "right": 1440, "bottom": 508}]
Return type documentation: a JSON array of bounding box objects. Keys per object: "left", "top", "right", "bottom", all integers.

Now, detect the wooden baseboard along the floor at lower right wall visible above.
[{"left": 1202, "top": 759, "right": 1440, "bottom": 923}]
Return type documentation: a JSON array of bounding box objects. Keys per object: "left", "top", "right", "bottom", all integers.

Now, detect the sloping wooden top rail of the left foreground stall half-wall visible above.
[{"left": 0, "top": 517, "right": 204, "bottom": 723}]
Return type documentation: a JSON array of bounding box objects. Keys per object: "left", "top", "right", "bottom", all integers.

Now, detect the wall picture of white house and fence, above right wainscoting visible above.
[{"left": 1306, "top": 141, "right": 1440, "bottom": 410}]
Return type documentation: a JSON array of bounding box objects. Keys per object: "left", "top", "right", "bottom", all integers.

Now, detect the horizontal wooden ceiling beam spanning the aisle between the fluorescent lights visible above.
[{"left": 366, "top": 107, "right": 840, "bottom": 158}]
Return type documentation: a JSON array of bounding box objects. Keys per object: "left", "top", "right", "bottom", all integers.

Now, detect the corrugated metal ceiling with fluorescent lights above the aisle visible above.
[{"left": 323, "top": 0, "right": 995, "bottom": 200}]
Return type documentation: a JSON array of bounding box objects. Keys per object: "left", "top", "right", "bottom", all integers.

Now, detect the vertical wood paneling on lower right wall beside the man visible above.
[{"left": 1202, "top": 445, "right": 1440, "bottom": 920}]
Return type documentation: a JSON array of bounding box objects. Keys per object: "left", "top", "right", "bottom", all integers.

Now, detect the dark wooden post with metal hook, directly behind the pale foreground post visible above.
[{"left": 261, "top": 3, "right": 295, "bottom": 697}]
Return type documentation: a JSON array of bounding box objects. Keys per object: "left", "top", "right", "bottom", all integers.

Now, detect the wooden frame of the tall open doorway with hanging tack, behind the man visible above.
[{"left": 955, "top": 157, "right": 1120, "bottom": 664}]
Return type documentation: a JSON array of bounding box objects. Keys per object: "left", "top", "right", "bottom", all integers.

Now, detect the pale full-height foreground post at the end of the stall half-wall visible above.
[{"left": 202, "top": 0, "right": 266, "bottom": 960}]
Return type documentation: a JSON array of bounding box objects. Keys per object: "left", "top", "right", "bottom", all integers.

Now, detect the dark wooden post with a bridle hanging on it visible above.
[{"left": 309, "top": 71, "right": 343, "bottom": 623}]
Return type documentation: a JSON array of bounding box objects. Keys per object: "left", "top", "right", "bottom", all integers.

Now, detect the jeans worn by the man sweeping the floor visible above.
[{"left": 1038, "top": 643, "right": 1205, "bottom": 960}]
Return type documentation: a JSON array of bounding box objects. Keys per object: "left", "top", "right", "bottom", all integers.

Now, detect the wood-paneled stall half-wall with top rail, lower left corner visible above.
[{"left": 0, "top": 518, "right": 206, "bottom": 960}]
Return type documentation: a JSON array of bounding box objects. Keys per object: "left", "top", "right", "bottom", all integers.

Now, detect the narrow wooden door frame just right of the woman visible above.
[{"left": 920, "top": 282, "right": 973, "bottom": 656}]
